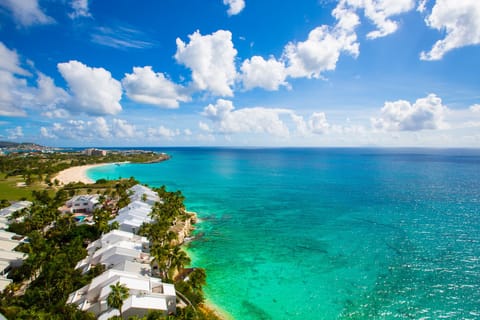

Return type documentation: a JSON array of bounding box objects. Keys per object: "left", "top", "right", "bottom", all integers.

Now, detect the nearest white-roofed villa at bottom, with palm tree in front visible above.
[{"left": 67, "top": 261, "right": 176, "bottom": 320}]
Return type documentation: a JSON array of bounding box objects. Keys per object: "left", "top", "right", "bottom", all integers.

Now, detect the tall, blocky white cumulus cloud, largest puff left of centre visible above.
[{"left": 175, "top": 30, "right": 237, "bottom": 96}]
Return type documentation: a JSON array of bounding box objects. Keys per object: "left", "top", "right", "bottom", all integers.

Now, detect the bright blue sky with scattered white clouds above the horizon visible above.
[{"left": 0, "top": 0, "right": 480, "bottom": 148}]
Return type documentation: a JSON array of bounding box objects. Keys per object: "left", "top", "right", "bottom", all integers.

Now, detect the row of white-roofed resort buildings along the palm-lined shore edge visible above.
[{"left": 67, "top": 185, "right": 177, "bottom": 320}]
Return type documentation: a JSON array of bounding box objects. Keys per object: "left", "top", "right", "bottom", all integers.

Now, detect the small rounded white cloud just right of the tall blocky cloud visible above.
[{"left": 241, "top": 56, "right": 288, "bottom": 91}]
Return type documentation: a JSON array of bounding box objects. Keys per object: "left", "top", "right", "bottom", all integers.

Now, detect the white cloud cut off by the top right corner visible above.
[{"left": 420, "top": 0, "right": 480, "bottom": 60}]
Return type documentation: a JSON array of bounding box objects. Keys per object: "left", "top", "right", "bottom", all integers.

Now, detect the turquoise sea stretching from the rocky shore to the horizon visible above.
[{"left": 89, "top": 148, "right": 480, "bottom": 319}]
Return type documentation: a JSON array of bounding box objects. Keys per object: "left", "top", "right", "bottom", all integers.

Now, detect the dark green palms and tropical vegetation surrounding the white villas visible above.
[{"left": 0, "top": 156, "right": 218, "bottom": 320}]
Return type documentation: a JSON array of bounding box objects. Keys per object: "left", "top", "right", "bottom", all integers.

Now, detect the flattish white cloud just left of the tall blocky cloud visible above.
[{"left": 122, "top": 66, "right": 190, "bottom": 108}]
